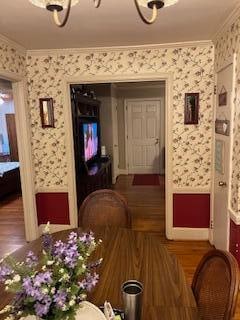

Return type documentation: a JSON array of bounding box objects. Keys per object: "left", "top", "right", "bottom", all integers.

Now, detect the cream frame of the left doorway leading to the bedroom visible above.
[{"left": 0, "top": 70, "right": 39, "bottom": 241}]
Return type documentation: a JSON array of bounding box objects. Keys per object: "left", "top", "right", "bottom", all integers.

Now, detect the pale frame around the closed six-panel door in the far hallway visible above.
[{"left": 124, "top": 97, "right": 166, "bottom": 174}]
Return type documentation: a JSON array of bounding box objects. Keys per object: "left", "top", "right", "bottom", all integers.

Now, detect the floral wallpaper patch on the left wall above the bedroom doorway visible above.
[{"left": 0, "top": 39, "right": 26, "bottom": 74}]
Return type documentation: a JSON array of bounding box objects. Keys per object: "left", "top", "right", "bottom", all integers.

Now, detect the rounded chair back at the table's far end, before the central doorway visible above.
[{"left": 79, "top": 189, "right": 131, "bottom": 229}]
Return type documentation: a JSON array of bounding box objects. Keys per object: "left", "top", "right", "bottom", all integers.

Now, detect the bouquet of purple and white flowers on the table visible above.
[{"left": 0, "top": 224, "right": 101, "bottom": 320}]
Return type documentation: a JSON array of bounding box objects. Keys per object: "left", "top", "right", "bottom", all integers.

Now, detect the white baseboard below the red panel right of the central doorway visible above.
[{"left": 172, "top": 228, "right": 209, "bottom": 240}]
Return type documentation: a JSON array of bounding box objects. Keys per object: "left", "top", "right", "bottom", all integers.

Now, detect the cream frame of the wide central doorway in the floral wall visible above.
[{"left": 63, "top": 73, "right": 173, "bottom": 239}]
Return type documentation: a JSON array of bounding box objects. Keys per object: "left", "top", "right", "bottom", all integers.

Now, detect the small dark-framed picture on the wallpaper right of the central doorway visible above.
[{"left": 184, "top": 93, "right": 199, "bottom": 125}]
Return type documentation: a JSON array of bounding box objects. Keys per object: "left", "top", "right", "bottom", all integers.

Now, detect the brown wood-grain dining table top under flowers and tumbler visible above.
[{"left": 0, "top": 228, "right": 199, "bottom": 320}]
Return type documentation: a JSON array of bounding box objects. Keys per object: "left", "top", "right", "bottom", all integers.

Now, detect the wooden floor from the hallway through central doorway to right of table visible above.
[{"left": 114, "top": 176, "right": 240, "bottom": 320}]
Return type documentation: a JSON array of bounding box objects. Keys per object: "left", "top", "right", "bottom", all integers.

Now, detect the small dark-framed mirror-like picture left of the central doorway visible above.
[{"left": 39, "top": 98, "right": 55, "bottom": 128}]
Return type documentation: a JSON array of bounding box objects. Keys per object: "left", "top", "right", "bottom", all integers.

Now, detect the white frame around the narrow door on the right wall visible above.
[{"left": 209, "top": 53, "right": 237, "bottom": 248}]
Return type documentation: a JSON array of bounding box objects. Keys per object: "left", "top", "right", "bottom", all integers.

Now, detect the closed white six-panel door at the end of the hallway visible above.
[{"left": 127, "top": 99, "right": 160, "bottom": 174}]
